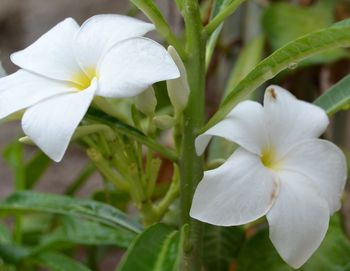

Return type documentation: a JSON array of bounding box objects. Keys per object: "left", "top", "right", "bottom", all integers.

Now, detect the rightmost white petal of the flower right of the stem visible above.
[{"left": 281, "top": 139, "right": 347, "bottom": 214}]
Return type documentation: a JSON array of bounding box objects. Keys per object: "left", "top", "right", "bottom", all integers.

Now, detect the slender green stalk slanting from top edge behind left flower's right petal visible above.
[{"left": 131, "top": 0, "right": 186, "bottom": 58}]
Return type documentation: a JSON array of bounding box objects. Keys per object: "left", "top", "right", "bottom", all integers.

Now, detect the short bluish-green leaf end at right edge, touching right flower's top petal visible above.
[{"left": 314, "top": 75, "right": 350, "bottom": 115}]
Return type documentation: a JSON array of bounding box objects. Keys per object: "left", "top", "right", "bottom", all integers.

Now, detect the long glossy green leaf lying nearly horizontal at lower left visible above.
[{"left": 0, "top": 191, "right": 140, "bottom": 233}]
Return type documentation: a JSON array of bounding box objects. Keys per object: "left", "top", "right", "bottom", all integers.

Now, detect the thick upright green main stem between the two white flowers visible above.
[{"left": 180, "top": 0, "right": 206, "bottom": 271}]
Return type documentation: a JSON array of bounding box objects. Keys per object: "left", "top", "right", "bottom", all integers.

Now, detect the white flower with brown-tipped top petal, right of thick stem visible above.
[{"left": 191, "top": 86, "right": 346, "bottom": 268}]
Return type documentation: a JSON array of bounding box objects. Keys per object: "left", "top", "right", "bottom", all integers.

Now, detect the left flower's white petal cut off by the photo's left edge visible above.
[{"left": 0, "top": 70, "right": 72, "bottom": 118}]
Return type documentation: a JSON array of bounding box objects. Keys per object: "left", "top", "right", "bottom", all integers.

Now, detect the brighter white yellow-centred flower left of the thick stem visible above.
[{"left": 0, "top": 14, "right": 179, "bottom": 161}]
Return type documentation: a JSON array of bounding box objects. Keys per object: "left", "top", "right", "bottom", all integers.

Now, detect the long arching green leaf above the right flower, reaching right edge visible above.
[{"left": 200, "top": 21, "right": 350, "bottom": 133}]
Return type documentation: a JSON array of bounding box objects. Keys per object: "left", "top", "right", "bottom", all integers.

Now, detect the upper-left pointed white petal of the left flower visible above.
[{"left": 11, "top": 18, "right": 81, "bottom": 81}]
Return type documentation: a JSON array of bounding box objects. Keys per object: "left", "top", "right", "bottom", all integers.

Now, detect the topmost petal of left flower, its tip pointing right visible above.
[{"left": 74, "top": 14, "right": 154, "bottom": 68}]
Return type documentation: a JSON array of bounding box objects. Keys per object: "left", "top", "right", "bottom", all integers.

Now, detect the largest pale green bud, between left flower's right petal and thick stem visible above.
[{"left": 167, "top": 46, "right": 190, "bottom": 111}]
